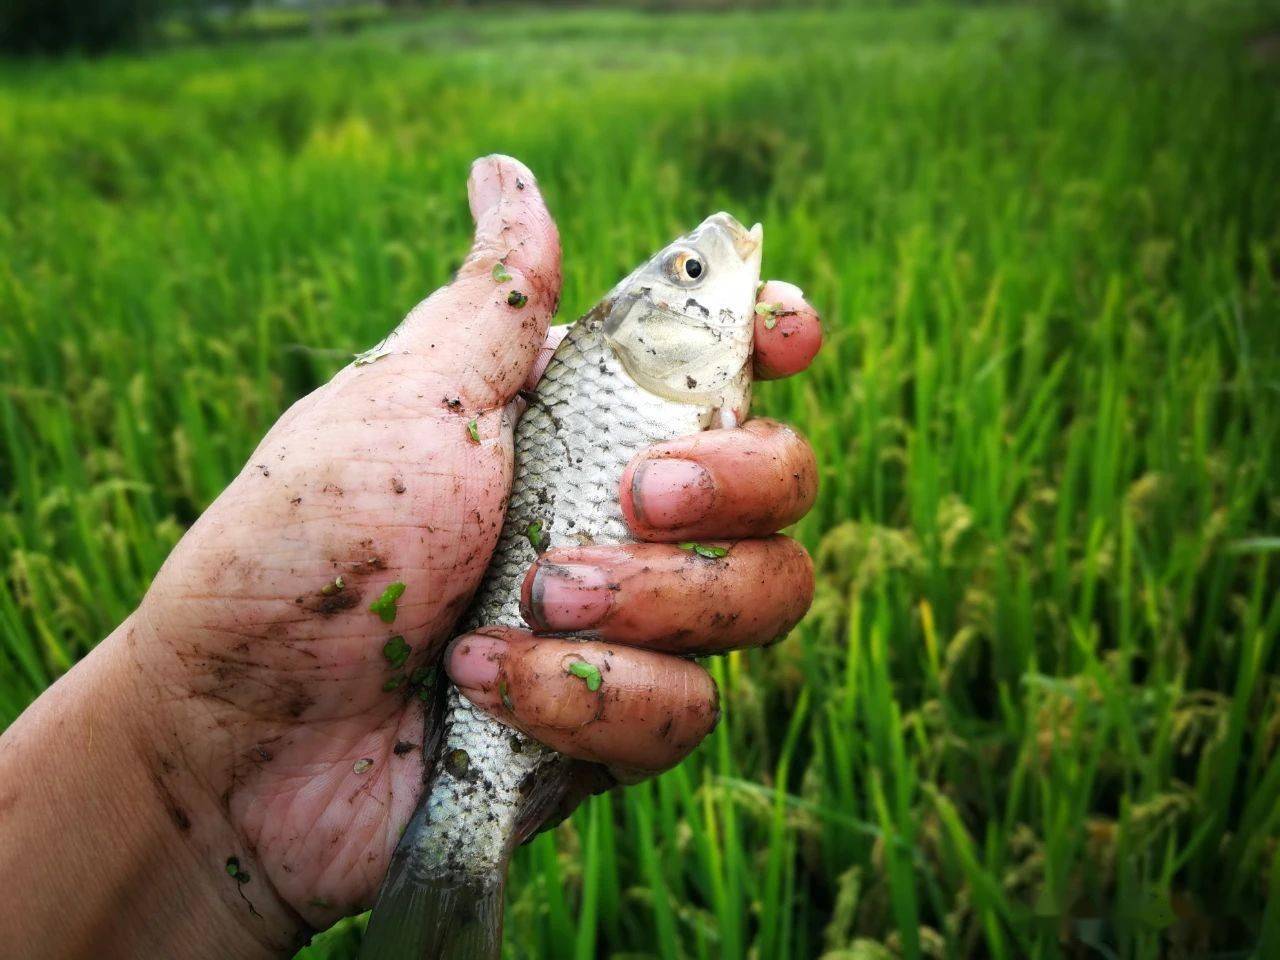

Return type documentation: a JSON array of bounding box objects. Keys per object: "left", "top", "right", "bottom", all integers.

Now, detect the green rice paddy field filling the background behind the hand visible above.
[{"left": 0, "top": 3, "right": 1280, "bottom": 960}]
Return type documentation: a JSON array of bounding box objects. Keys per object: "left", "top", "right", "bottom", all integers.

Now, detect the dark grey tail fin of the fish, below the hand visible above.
[{"left": 360, "top": 864, "right": 506, "bottom": 960}]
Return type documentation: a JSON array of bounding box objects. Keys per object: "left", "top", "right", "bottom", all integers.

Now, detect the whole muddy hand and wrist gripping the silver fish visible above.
[{"left": 0, "top": 157, "right": 820, "bottom": 957}]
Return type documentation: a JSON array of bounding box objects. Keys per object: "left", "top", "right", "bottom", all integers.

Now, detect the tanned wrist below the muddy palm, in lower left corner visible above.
[{"left": 0, "top": 616, "right": 301, "bottom": 957}]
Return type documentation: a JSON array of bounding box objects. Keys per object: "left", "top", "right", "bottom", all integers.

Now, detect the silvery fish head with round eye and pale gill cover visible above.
[{"left": 604, "top": 212, "right": 764, "bottom": 426}]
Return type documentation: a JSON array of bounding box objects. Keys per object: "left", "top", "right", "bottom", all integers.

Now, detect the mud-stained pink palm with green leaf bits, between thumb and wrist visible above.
[{"left": 141, "top": 345, "right": 511, "bottom": 920}]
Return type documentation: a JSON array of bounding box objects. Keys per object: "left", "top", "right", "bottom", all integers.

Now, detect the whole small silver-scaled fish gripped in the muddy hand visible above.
[{"left": 360, "top": 212, "right": 763, "bottom": 960}]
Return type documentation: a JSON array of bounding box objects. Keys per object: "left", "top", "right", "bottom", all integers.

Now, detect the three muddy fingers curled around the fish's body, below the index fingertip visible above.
[{"left": 445, "top": 420, "right": 817, "bottom": 798}]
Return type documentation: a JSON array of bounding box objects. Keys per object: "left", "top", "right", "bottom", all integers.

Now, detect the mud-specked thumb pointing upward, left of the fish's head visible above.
[{"left": 387, "top": 155, "right": 561, "bottom": 408}]
